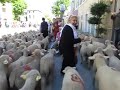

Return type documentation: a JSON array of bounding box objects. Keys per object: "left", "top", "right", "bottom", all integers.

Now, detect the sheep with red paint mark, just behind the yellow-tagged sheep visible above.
[{"left": 9, "top": 49, "right": 44, "bottom": 89}]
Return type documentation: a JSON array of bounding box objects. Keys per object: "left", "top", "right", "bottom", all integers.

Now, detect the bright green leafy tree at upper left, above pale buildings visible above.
[{"left": 13, "top": 0, "right": 27, "bottom": 20}]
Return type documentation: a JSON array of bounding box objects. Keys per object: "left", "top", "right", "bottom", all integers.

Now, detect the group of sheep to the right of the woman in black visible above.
[{"left": 79, "top": 36, "right": 120, "bottom": 90}]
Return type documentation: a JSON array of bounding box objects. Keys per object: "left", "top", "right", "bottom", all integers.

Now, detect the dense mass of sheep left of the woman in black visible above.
[{"left": 0, "top": 31, "right": 56, "bottom": 90}]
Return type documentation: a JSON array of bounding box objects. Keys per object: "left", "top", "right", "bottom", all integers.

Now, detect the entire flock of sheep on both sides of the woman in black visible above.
[{"left": 0, "top": 30, "right": 120, "bottom": 90}]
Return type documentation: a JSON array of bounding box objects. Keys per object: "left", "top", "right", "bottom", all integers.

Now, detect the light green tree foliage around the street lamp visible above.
[{"left": 52, "top": 0, "right": 70, "bottom": 17}]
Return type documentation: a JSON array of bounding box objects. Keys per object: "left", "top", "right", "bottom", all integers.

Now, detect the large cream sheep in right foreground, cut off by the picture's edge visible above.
[{"left": 95, "top": 55, "right": 120, "bottom": 90}]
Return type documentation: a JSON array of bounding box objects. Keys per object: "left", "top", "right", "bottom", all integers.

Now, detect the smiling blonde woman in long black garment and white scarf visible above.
[{"left": 59, "top": 15, "right": 84, "bottom": 74}]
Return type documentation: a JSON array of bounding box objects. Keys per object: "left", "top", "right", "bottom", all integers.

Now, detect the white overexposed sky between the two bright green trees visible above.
[{"left": 25, "top": 0, "right": 56, "bottom": 17}]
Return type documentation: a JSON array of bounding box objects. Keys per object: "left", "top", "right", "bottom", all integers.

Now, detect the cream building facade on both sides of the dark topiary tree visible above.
[{"left": 71, "top": 0, "right": 120, "bottom": 39}]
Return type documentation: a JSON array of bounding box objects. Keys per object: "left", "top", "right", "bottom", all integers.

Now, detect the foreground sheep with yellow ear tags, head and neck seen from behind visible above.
[{"left": 19, "top": 69, "right": 41, "bottom": 90}]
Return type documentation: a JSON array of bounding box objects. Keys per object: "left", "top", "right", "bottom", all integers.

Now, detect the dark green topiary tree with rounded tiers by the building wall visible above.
[{"left": 88, "top": 2, "right": 108, "bottom": 37}]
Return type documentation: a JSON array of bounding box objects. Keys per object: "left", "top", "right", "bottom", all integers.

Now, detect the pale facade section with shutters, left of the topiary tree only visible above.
[{"left": 71, "top": 0, "right": 99, "bottom": 35}]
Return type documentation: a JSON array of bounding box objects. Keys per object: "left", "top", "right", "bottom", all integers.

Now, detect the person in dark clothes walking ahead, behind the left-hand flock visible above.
[{"left": 40, "top": 18, "right": 48, "bottom": 38}]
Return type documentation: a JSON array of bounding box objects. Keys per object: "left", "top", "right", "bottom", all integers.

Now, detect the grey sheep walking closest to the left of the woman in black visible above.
[{"left": 40, "top": 49, "right": 56, "bottom": 90}]
